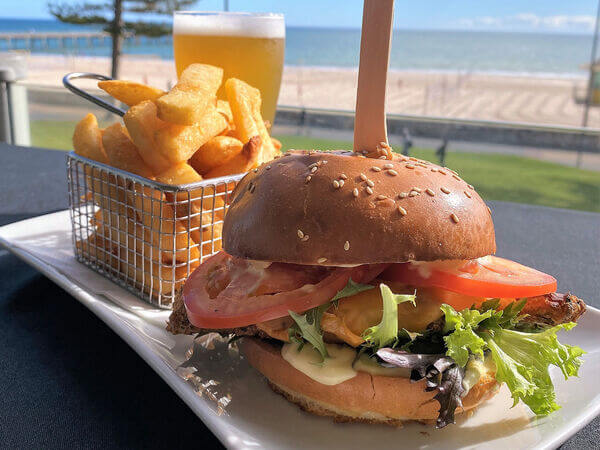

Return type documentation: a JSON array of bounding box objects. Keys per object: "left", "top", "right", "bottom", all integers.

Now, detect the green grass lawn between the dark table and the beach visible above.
[{"left": 31, "top": 121, "right": 600, "bottom": 212}]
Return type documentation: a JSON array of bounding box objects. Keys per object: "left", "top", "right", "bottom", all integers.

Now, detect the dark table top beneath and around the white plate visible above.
[{"left": 0, "top": 143, "right": 600, "bottom": 449}]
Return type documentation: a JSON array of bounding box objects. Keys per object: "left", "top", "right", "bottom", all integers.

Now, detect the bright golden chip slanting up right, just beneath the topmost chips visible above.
[{"left": 154, "top": 106, "right": 227, "bottom": 164}]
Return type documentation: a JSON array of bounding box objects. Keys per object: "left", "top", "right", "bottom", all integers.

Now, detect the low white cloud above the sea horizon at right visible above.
[{"left": 457, "top": 13, "right": 596, "bottom": 32}]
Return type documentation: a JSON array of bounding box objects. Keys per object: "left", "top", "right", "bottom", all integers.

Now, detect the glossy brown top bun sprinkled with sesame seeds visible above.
[{"left": 223, "top": 151, "right": 496, "bottom": 266}]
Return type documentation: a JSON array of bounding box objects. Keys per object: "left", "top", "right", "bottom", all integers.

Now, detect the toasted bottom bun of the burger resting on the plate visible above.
[{"left": 241, "top": 338, "right": 498, "bottom": 425}]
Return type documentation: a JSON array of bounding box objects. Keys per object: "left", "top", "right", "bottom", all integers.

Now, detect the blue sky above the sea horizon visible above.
[{"left": 0, "top": 0, "right": 598, "bottom": 33}]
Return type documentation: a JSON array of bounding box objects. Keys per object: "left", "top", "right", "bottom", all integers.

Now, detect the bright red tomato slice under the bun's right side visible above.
[{"left": 381, "top": 256, "right": 556, "bottom": 299}]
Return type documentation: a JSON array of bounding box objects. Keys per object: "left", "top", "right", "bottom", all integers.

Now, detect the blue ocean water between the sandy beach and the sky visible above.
[{"left": 0, "top": 19, "right": 592, "bottom": 76}]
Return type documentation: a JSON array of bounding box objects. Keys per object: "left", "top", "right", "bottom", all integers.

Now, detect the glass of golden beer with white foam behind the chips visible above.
[{"left": 173, "top": 11, "right": 285, "bottom": 123}]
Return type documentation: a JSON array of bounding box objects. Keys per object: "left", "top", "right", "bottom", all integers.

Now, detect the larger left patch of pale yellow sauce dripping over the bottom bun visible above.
[{"left": 281, "top": 344, "right": 357, "bottom": 386}]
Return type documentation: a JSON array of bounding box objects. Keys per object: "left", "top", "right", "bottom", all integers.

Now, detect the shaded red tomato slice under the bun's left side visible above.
[{"left": 183, "top": 252, "right": 387, "bottom": 329}]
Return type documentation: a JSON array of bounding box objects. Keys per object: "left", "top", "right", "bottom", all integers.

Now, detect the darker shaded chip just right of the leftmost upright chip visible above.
[{"left": 102, "top": 123, "right": 153, "bottom": 178}]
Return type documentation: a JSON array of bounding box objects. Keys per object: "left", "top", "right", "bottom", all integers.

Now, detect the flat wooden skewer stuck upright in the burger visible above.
[{"left": 354, "top": 0, "right": 394, "bottom": 152}]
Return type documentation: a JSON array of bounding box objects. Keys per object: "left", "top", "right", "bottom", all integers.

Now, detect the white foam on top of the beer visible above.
[{"left": 173, "top": 12, "right": 285, "bottom": 39}]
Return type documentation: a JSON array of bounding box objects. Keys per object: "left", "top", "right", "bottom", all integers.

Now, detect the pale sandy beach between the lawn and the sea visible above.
[{"left": 26, "top": 55, "right": 600, "bottom": 128}]
